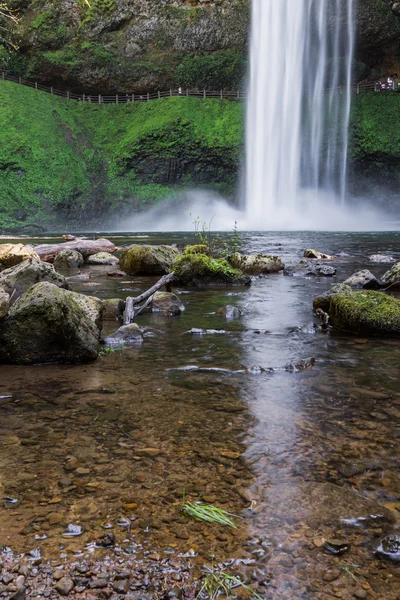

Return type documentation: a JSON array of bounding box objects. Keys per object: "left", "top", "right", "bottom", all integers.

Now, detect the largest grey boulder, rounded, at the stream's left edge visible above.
[{"left": 0, "top": 281, "right": 100, "bottom": 364}]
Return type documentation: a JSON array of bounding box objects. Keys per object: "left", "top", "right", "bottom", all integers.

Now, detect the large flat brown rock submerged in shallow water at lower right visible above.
[{"left": 265, "top": 481, "right": 394, "bottom": 528}]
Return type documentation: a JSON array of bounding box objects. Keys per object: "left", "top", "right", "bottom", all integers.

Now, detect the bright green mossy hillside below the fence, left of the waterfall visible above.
[{"left": 0, "top": 81, "right": 243, "bottom": 228}]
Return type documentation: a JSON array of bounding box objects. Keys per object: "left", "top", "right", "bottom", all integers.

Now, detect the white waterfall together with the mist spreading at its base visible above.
[{"left": 123, "top": 0, "right": 398, "bottom": 231}]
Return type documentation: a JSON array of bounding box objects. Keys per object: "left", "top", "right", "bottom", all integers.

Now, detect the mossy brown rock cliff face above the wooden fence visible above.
[{"left": 0, "top": 0, "right": 400, "bottom": 93}]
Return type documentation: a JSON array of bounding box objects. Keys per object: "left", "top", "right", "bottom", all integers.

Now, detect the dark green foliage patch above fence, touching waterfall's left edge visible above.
[{"left": 176, "top": 50, "right": 247, "bottom": 90}]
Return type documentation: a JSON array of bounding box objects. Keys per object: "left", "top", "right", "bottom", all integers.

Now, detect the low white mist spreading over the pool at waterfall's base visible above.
[{"left": 120, "top": 190, "right": 400, "bottom": 232}]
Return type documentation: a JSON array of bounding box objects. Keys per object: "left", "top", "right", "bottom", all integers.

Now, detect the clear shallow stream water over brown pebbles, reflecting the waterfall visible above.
[{"left": 0, "top": 232, "right": 400, "bottom": 600}]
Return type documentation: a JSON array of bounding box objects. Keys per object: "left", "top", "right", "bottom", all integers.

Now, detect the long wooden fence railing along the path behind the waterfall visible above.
[{"left": 0, "top": 71, "right": 400, "bottom": 104}]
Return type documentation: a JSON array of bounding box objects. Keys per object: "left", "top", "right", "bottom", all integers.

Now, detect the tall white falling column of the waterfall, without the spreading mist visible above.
[{"left": 246, "top": 0, "right": 354, "bottom": 229}]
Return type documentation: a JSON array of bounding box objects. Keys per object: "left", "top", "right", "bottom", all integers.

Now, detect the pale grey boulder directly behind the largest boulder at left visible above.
[{"left": 0, "top": 258, "right": 68, "bottom": 302}]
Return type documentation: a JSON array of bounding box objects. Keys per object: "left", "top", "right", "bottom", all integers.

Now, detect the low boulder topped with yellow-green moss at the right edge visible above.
[{"left": 328, "top": 290, "right": 400, "bottom": 336}]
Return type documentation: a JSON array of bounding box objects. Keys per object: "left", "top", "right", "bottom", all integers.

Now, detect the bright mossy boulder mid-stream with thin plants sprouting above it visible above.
[{"left": 173, "top": 254, "right": 251, "bottom": 287}]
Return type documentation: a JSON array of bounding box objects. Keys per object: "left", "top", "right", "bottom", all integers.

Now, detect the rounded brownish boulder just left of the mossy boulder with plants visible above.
[{"left": 120, "top": 245, "right": 180, "bottom": 275}]
